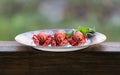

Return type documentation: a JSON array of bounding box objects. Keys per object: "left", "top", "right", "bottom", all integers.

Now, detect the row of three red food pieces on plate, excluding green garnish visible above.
[{"left": 32, "top": 30, "right": 87, "bottom": 47}]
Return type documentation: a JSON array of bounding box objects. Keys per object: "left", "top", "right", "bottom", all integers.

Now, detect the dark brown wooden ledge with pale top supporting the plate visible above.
[{"left": 0, "top": 41, "right": 120, "bottom": 75}]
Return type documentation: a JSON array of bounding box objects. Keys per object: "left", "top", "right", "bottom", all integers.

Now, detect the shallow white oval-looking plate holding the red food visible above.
[{"left": 15, "top": 29, "right": 106, "bottom": 52}]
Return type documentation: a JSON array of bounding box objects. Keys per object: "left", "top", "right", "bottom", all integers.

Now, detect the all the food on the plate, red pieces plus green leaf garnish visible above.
[{"left": 32, "top": 27, "right": 95, "bottom": 47}]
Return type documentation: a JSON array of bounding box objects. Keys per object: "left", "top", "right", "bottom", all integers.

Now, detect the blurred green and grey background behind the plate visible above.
[{"left": 0, "top": 0, "right": 120, "bottom": 41}]
